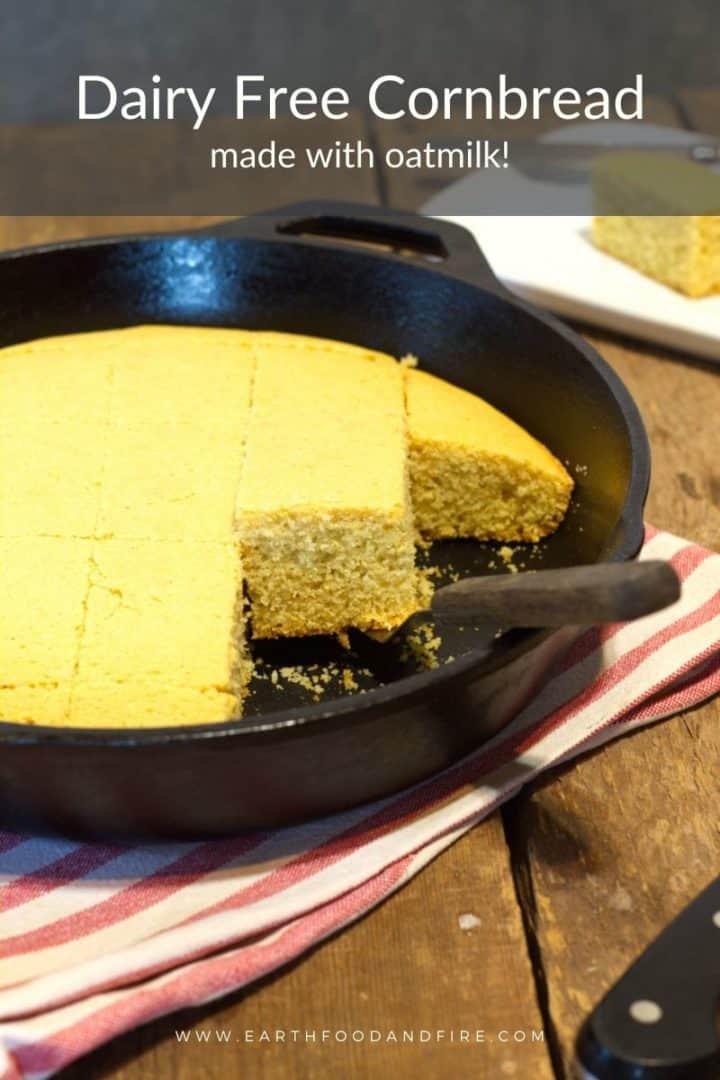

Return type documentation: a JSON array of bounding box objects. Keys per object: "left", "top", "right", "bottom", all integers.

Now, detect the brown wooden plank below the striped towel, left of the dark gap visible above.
[{"left": 62, "top": 815, "right": 553, "bottom": 1080}]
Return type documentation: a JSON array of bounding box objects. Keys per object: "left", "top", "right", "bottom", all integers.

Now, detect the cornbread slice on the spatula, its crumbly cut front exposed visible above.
[{"left": 236, "top": 338, "right": 418, "bottom": 637}]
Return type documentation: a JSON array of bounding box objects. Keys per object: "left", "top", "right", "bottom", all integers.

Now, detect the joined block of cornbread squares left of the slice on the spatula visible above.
[{"left": 0, "top": 327, "right": 255, "bottom": 727}]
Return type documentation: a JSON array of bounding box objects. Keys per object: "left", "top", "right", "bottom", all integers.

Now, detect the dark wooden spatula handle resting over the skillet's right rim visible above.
[{"left": 432, "top": 562, "right": 680, "bottom": 627}]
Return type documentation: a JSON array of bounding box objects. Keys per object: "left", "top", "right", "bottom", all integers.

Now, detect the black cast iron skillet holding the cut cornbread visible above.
[{"left": 0, "top": 204, "right": 650, "bottom": 837}]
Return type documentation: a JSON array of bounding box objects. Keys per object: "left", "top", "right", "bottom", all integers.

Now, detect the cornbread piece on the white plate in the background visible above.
[{"left": 593, "top": 152, "right": 720, "bottom": 297}]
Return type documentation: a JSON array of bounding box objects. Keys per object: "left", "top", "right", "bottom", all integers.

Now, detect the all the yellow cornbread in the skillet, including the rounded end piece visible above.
[{"left": 0, "top": 327, "right": 571, "bottom": 727}]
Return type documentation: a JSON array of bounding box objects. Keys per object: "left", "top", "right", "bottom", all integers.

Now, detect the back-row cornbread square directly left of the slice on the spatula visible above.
[{"left": 97, "top": 326, "right": 255, "bottom": 541}]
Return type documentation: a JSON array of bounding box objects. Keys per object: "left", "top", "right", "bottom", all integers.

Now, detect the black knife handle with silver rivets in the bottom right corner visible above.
[{"left": 578, "top": 878, "right": 720, "bottom": 1080}]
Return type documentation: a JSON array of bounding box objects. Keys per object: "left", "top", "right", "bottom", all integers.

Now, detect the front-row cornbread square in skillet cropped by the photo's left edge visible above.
[{"left": 0, "top": 537, "right": 92, "bottom": 724}]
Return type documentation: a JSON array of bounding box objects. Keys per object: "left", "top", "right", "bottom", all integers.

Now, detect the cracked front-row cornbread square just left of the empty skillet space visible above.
[{"left": 69, "top": 540, "right": 244, "bottom": 727}]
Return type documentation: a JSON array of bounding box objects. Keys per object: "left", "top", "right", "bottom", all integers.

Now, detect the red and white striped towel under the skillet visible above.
[{"left": 0, "top": 529, "right": 720, "bottom": 1080}]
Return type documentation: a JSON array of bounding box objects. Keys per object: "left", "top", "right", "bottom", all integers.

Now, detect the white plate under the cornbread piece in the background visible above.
[{"left": 424, "top": 124, "right": 720, "bottom": 361}]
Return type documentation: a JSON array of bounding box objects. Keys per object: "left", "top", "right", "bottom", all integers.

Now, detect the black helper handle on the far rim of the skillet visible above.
[{"left": 203, "top": 202, "right": 508, "bottom": 296}]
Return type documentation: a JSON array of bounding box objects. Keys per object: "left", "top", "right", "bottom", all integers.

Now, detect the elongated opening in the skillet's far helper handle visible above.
[{"left": 276, "top": 214, "right": 448, "bottom": 262}]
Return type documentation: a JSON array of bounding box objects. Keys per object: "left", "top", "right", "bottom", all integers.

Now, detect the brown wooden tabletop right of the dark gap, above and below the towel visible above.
[{"left": 511, "top": 333, "right": 720, "bottom": 1078}]
